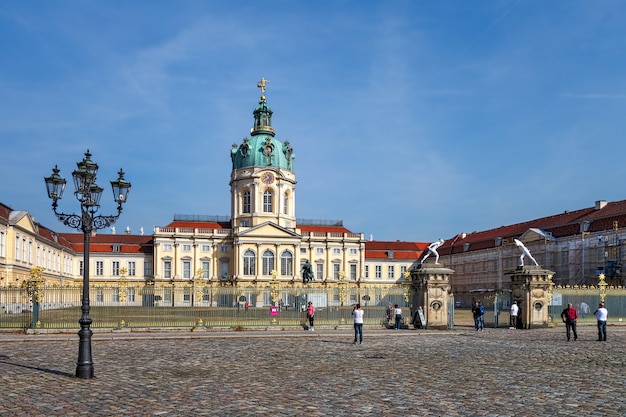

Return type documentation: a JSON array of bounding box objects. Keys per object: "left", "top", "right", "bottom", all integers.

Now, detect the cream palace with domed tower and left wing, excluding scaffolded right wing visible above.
[{"left": 0, "top": 79, "right": 428, "bottom": 298}]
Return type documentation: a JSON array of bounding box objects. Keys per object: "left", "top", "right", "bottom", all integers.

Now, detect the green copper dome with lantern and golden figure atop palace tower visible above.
[{"left": 230, "top": 79, "right": 295, "bottom": 172}]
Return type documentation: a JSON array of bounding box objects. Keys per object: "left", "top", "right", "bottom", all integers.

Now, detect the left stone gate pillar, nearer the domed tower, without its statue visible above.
[{"left": 411, "top": 263, "right": 454, "bottom": 330}]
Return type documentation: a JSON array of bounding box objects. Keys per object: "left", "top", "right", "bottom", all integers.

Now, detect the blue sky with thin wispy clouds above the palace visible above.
[{"left": 0, "top": 0, "right": 626, "bottom": 241}]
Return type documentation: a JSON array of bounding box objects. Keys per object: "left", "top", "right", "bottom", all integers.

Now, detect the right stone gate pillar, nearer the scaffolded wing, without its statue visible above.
[{"left": 504, "top": 265, "right": 554, "bottom": 329}]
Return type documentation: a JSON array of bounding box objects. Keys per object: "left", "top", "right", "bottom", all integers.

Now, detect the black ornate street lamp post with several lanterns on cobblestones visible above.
[{"left": 44, "top": 150, "right": 130, "bottom": 379}]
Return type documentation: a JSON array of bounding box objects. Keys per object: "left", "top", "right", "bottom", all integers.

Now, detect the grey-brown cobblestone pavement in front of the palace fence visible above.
[{"left": 0, "top": 326, "right": 626, "bottom": 417}]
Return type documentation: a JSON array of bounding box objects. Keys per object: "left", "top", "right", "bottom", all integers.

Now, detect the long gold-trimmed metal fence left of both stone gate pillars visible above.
[{"left": 0, "top": 285, "right": 405, "bottom": 330}]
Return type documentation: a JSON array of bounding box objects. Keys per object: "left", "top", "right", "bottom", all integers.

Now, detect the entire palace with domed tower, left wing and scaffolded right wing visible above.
[{"left": 0, "top": 79, "right": 626, "bottom": 305}]
